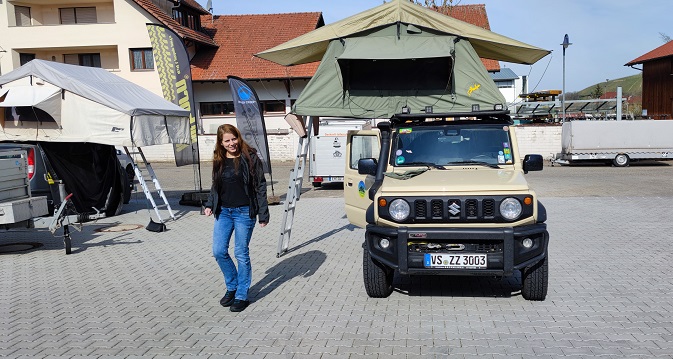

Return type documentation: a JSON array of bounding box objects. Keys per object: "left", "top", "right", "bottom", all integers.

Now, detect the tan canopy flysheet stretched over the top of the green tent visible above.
[{"left": 256, "top": 0, "right": 550, "bottom": 66}]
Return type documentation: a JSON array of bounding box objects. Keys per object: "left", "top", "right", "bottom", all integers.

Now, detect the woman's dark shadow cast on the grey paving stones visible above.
[{"left": 249, "top": 250, "right": 327, "bottom": 299}]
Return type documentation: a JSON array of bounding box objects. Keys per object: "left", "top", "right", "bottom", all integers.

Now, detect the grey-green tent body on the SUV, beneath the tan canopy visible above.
[{"left": 292, "top": 25, "right": 505, "bottom": 118}]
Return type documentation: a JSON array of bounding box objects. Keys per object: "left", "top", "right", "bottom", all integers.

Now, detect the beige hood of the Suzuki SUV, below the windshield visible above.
[{"left": 381, "top": 167, "right": 529, "bottom": 194}]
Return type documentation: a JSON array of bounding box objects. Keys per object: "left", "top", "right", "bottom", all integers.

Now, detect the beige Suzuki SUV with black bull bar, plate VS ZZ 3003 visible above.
[{"left": 344, "top": 111, "right": 549, "bottom": 300}]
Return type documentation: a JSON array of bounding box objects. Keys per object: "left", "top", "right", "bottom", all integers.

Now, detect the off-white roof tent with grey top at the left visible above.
[{"left": 0, "top": 60, "right": 191, "bottom": 147}]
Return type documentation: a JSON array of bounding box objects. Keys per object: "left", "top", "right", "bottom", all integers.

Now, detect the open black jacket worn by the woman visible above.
[{"left": 204, "top": 152, "right": 269, "bottom": 223}]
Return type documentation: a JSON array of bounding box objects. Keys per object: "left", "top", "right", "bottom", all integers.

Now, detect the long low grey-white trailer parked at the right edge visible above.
[{"left": 556, "top": 120, "right": 673, "bottom": 167}]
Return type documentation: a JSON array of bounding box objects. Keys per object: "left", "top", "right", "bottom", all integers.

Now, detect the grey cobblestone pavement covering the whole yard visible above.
[{"left": 0, "top": 164, "right": 673, "bottom": 359}]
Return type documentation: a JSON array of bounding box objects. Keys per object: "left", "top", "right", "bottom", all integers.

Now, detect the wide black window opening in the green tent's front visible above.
[{"left": 339, "top": 57, "right": 453, "bottom": 91}]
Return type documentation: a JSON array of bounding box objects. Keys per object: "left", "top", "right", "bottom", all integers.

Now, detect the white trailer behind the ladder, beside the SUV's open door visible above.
[{"left": 309, "top": 119, "right": 372, "bottom": 187}]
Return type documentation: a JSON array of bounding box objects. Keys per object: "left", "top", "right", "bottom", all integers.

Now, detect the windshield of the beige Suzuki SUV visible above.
[{"left": 391, "top": 124, "right": 514, "bottom": 169}]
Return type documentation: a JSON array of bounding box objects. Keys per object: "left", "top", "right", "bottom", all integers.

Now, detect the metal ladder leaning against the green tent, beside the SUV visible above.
[{"left": 276, "top": 118, "right": 313, "bottom": 258}]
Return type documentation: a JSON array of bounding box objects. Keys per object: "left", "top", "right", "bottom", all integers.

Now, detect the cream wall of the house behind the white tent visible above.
[{"left": 0, "top": 0, "right": 162, "bottom": 95}]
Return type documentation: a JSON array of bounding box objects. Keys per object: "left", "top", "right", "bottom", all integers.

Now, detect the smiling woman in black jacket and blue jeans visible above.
[{"left": 204, "top": 125, "right": 269, "bottom": 312}]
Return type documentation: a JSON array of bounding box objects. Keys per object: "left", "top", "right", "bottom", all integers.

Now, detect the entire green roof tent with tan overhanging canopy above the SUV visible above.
[{"left": 256, "top": 0, "right": 549, "bottom": 118}]
